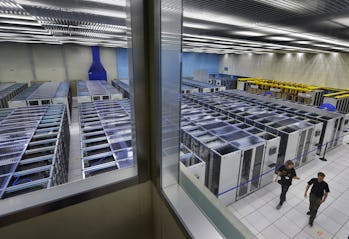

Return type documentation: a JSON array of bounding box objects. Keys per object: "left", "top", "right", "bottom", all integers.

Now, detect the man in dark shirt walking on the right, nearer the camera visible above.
[{"left": 304, "top": 172, "right": 330, "bottom": 227}]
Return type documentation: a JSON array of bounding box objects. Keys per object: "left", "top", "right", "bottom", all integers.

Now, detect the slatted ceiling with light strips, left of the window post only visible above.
[{"left": 0, "top": 0, "right": 127, "bottom": 47}]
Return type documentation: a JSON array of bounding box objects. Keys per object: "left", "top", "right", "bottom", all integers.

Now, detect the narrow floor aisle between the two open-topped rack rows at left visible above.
[{"left": 68, "top": 97, "right": 82, "bottom": 182}]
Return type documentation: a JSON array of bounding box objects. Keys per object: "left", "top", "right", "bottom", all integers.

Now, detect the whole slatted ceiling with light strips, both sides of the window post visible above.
[{"left": 0, "top": 0, "right": 349, "bottom": 54}]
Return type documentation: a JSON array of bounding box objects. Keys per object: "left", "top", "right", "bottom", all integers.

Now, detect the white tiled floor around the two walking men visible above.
[{"left": 228, "top": 136, "right": 349, "bottom": 239}]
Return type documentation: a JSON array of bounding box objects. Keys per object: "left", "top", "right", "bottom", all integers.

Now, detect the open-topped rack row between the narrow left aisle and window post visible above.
[{"left": 79, "top": 100, "right": 133, "bottom": 178}]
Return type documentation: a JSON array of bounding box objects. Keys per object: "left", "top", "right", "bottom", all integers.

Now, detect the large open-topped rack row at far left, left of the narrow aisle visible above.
[{"left": 0, "top": 104, "right": 70, "bottom": 198}]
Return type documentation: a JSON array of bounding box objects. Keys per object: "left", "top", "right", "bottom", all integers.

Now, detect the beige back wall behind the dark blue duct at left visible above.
[{"left": 0, "top": 43, "right": 117, "bottom": 83}]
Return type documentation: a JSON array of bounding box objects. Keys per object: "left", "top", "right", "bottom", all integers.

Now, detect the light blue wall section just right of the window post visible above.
[{"left": 182, "top": 52, "right": 220, "bottom": 77}]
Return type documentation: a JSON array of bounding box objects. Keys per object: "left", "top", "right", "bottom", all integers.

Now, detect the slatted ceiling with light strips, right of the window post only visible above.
[{"left": 183, "top": 0, "right": 349, "bottom": 54}]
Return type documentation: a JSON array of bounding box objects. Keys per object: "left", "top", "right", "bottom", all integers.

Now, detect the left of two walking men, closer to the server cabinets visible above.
[{"left": 275, "top": 160, "right": 299, "bottom": 209}]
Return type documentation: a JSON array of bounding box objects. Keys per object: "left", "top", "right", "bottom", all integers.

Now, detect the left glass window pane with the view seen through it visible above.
[{"left": 0, "top": 0, "right": 137, "bottom": 207}]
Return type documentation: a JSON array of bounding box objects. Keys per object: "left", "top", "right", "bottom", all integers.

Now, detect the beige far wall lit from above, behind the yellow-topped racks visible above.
[{"left": 219, "top": 53, "right": 349, "bottom": 89}]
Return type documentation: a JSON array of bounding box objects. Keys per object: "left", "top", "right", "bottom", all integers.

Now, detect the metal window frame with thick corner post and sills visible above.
[{"left": 0, "top": 0, "right": 230, "bottom": 238}]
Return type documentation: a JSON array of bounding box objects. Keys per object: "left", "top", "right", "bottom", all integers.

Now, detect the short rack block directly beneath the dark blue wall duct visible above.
[{"left": 76, "top": 80, "right": 122, "bottom": 103}]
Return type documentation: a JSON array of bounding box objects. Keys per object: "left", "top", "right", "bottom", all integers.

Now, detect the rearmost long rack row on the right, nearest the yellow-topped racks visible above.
[{"left": 222, "top": 91, "right": 349, "bottom": 154}]
